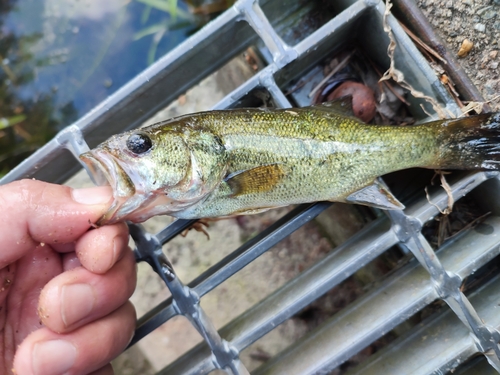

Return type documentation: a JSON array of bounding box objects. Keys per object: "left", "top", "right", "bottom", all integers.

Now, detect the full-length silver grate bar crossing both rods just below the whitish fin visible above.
[{"left": 154, "top": 173, "right": 498, "bottom": 374}]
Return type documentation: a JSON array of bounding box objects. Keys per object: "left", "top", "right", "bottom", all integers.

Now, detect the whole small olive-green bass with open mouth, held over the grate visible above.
[{"left": 80, "top": 97, "right": 500, "bottom": 225}]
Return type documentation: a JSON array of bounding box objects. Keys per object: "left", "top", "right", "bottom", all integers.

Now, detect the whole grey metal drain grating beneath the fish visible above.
[{"left": 1, "top": 0, "right": 500, "bottom": 375}]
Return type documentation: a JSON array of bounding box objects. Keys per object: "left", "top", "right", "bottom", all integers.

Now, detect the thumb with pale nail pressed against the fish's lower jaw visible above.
[{"left": 0, "top": 180, "right": 112, "bottom": 268}]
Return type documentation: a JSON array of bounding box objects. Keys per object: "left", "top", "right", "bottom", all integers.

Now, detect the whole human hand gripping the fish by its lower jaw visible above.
[{"left": 0, "top": 180, "right": 136, "bottom": 375}]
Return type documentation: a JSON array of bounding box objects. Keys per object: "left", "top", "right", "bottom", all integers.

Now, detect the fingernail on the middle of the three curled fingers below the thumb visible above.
[{"left": 61, "top": 284, "right": 95, "bottom": 327}]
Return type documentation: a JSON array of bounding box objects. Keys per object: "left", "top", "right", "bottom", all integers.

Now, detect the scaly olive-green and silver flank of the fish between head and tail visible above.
[{"left": 177, "top": 109, "right": 437, "bottom": 218}]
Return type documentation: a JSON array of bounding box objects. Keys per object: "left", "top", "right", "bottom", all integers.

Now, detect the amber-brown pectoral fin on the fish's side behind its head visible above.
[{"left": 225, "top": 164, "right": 285, "bottom": 197}]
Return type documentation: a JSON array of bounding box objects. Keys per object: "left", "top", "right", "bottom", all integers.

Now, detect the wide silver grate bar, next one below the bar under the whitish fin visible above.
[{"left": 253, "top": 217, "right": 500, "bottom": 375}]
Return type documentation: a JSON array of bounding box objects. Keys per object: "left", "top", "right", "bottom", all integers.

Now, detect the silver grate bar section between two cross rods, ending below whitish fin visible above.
[{"left": 162, "top": 217, "right": 397, "bottom": 375}]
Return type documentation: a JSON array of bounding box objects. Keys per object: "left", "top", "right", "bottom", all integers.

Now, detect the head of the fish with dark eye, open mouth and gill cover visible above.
[{"left": 80, "top": 127, "right": 206, "bottom": 225}]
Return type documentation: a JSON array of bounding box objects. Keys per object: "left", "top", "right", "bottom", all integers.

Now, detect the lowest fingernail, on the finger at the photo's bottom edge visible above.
[{"left": 32, "top": 340, "right": 77, "bottom": 375}]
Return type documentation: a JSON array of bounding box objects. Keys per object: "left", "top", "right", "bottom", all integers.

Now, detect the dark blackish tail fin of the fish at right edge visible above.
[{"left": 438, "top": 113, "right": 500, "bottom": 170}]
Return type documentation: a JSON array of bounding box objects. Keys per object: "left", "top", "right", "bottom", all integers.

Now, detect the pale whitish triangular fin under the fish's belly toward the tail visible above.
[{"left": 346, "top": 180, "right": 405, "bottom": 210}]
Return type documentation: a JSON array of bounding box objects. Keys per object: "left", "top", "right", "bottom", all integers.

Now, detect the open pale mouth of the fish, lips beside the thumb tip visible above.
[{"left": 80, "top": 150, "right": 136, "bottom": 225}]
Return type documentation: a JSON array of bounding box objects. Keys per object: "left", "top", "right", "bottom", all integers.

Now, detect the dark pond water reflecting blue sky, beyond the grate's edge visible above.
[{"left": 0, "top": 0, "right": 232, "bottom": 176}]
